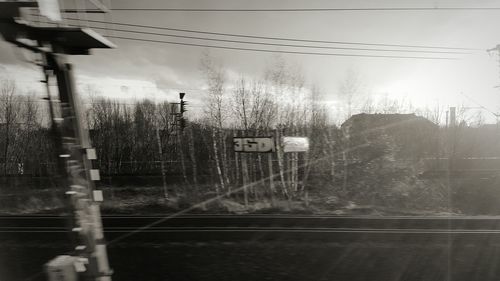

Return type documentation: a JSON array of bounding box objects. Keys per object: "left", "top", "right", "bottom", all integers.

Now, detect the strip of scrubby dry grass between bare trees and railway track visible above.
[{"left": 0, "top": 183, "right": 458, "bottom": 215}]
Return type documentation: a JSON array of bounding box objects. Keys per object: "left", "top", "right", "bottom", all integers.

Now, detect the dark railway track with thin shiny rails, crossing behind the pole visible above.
[{"left": 0, "top": 215, "right": 500, "bottom": 243}]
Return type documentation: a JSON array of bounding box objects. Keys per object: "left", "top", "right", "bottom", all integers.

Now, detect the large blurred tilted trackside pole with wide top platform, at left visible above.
[{"left": 0, "top": 1, "right": 114, "bottom": 281}]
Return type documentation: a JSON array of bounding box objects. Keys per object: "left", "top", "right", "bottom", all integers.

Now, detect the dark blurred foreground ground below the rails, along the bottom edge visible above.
[{"left": 0, "top": 238, "right": 500, "bottom": 281}]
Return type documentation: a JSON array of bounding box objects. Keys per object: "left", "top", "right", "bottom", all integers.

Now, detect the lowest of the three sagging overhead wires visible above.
[{"left": 106, "top": 36, "right": 457, "bottom": 60}]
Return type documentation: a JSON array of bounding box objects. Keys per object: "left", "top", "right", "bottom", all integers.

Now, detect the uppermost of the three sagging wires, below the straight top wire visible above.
[{"left": 57, "top": 18, "right": 479, "bottom": 51}]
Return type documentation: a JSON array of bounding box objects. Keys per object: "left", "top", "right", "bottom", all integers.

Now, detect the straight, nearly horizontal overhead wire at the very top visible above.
[{"left": 61, "top": 7, "right": 500, "bottom": 13}]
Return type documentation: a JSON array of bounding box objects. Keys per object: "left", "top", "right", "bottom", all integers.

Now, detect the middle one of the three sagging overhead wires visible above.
[{"left": 33, "top": 21, "right": 470, "bottom": 54}]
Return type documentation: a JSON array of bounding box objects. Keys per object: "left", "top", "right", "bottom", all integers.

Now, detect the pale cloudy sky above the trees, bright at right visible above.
[{"left": 0, "top": 0, "right": 500, "bottom": 121}]
